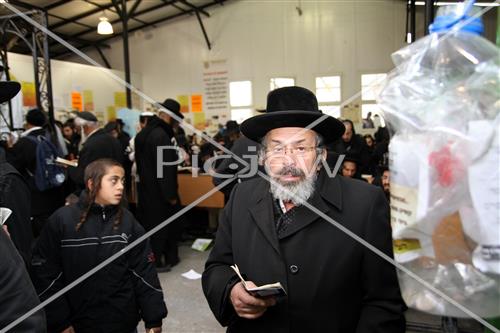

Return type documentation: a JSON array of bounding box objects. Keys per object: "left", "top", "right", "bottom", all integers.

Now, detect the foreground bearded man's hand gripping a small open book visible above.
[{"left": 229, "top": 281, "right": 276, "bottom": 319}]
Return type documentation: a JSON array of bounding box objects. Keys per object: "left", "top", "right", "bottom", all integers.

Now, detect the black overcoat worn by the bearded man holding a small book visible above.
[{"left": 202, "top": 172, "right": 406, "bottom": 333}]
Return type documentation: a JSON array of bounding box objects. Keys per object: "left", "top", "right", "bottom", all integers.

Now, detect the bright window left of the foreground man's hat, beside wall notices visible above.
[{"left": 229, "top": 81, "right": 253, "bottom": 124}]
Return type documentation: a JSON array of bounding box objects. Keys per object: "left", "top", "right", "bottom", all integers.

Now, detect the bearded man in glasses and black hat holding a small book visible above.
[{"left": 202, "top": 87, "right": 405, "bottom": 333}]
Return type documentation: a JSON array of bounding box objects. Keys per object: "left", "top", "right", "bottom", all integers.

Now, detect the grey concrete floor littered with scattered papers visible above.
[{"left": 138, "top": 243, "right": 483, "bottom": 333}]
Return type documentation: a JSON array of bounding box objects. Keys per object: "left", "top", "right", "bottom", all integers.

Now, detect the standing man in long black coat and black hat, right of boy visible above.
[{"left": 135, "top": 98, "right": 184, "bottom": 272}]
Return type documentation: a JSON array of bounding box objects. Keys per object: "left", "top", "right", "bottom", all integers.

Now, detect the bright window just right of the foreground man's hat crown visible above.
[{"left": 316, "top": 76, "right": 342, "bottom": 118}]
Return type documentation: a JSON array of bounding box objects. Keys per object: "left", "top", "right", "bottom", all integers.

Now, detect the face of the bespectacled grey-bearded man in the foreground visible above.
[{"left": 265, "top": 127, "right": 316, "bottom": 184}]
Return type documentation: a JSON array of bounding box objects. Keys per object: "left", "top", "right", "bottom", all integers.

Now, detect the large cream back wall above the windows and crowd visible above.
[{"left": 66, "top": 0, "right": 406, "bottom": 122}]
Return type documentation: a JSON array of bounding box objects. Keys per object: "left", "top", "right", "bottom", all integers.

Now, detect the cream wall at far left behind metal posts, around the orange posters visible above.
[{"left": 8, "top": 53, "right": 142, "bottom": 120}]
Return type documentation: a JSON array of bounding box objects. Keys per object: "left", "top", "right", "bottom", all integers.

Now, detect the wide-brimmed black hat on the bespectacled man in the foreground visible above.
[{"left": 240, "top": 86, "right": 345, "bottom": 143}]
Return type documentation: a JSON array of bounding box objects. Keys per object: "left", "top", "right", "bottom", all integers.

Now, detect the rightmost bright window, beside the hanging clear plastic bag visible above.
[{"left": 361, "top": 73, "right": 387, "bottom": 129}]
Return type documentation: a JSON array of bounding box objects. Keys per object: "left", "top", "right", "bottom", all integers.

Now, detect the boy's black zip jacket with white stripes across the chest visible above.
[{"left": 33, "top": 196, "right": 167, "bottom": 333}]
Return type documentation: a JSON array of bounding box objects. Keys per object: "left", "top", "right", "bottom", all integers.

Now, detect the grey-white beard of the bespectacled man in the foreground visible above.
[{"left": 270, "top": 173, "right": 316, "bottom": 206}]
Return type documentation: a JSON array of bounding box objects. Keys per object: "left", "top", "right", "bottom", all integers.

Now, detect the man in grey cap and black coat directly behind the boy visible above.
[{"left": 69, "top": 111, "right": 124, "bottom": 192}]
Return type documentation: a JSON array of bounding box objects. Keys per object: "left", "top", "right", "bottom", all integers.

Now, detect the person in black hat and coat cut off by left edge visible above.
[{"left": 0, "top": 81, "right": 46, "bottom": 333}]
